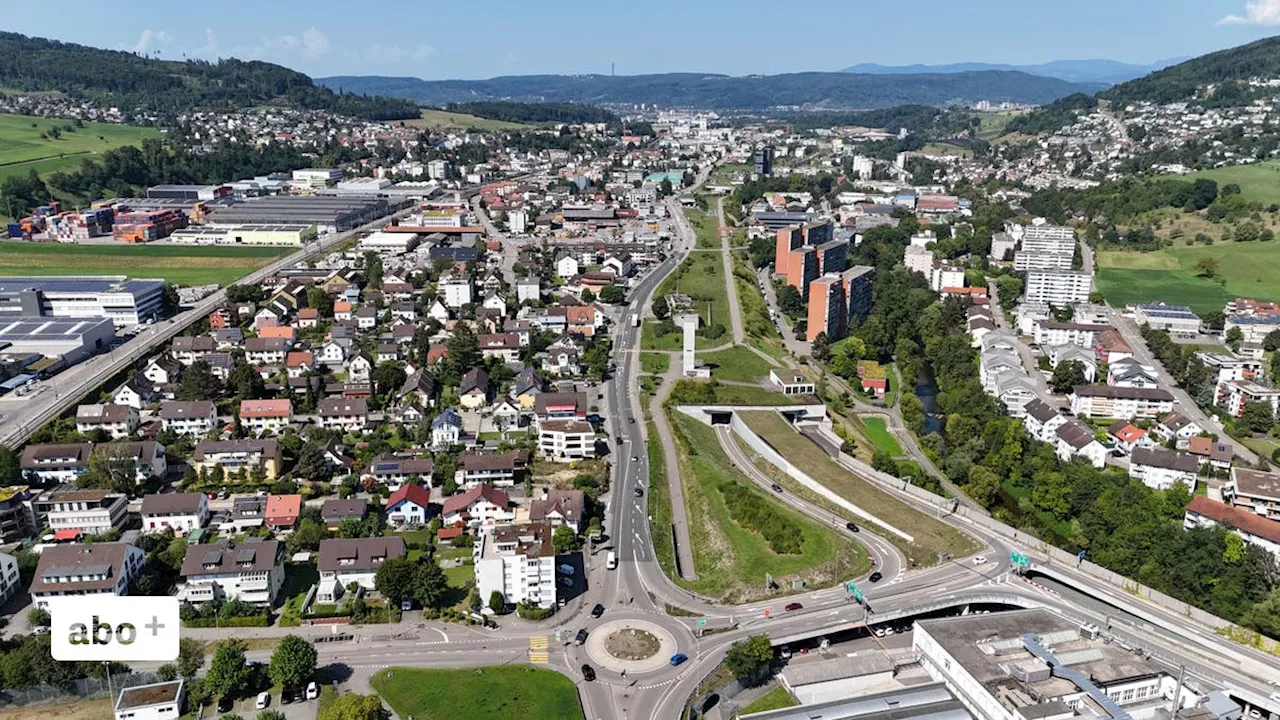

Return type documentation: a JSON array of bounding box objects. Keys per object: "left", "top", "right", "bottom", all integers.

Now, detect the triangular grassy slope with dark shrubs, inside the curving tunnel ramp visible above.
[{"left": 669, "top": 413, "right": 869, "bottom": 602}]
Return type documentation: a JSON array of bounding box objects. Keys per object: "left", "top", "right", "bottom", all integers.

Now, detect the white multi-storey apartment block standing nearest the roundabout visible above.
[{"left": 474, "top": 523, "right": 556, "bottom": 609}]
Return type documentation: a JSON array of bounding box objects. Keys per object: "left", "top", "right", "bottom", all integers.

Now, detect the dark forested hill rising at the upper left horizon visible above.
[{"left": 0, "top": 32, "right": 419, "bottom": 120}]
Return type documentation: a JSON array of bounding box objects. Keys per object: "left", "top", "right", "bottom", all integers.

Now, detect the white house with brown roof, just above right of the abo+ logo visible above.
[{"left": 178, "top": 541, "right": 284, "bottom": 605}]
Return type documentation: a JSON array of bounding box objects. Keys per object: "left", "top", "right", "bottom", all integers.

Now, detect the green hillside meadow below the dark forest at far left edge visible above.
[{"left": 0, "top": 114, "right": 160, "bottom": 179}]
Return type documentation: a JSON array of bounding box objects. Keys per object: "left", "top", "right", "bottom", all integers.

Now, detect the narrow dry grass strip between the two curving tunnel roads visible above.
[{"left": 741, "top": 413, "right": 979, "bottom": 565}]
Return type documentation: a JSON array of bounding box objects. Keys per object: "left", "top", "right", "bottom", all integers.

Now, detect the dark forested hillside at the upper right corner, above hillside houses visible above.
[{"left": 1100, "top": 36, "right": 1280, "bottom": 104}]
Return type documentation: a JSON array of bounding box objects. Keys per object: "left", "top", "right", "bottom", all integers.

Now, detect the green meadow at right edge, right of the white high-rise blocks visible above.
[{"left": 1097, "top": 242, "right": 1280, "bottom": 311}]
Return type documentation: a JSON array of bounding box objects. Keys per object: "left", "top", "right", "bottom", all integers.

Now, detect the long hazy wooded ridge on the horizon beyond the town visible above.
[{"left": 316, "top": 70, "right": 1105, "bottom": 110}]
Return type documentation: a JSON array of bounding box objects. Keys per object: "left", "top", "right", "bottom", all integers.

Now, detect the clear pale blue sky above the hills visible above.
[{"left": 4, "top": 0, "right": 1280, "bottom": 79}]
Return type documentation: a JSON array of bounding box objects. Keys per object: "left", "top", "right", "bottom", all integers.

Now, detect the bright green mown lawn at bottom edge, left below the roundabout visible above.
[{"left": 369, "top": 665, "right": 582, "bottom": 720}]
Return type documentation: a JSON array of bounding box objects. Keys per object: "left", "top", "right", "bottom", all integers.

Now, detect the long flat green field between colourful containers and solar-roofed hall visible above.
[{"left": 0, "top": 241, "right": 292, "bottom": 286}]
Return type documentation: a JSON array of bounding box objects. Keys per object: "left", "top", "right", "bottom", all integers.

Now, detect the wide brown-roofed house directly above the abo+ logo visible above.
[{"left": 28, "top": 542, "right": 146, "bottom": 610}]
